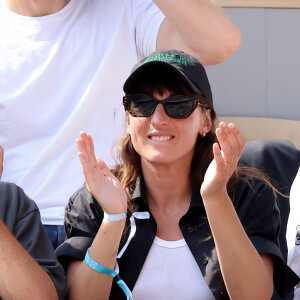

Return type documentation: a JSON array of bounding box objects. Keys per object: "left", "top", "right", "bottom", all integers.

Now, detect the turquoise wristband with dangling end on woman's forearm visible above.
[{"left": 84, "top": 248, "right": 133, "bottom": 300}]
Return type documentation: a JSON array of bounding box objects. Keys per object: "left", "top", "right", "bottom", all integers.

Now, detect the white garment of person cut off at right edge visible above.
[{"left": 286, "top": 168, "right": 300, "bottom": 300}]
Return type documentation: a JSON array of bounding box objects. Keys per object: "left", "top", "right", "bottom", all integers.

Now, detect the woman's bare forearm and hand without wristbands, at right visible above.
[{"left": 201, "top": 123, "right": 273, "bottom": 300}]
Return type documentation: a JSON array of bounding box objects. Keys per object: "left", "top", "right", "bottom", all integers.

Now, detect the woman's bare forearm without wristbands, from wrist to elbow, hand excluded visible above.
[{"left": 205, "top": 195, "right": 273, "bottom": 300}]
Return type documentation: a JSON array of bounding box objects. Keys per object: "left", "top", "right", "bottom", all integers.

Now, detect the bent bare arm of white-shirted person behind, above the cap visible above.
[{"left": 154, "top": 0, "right": 241, "bottom": 65}]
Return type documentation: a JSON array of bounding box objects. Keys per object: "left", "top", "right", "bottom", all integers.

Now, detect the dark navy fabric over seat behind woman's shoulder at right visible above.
[{"left": 240, "top": 140, "right": 300, "bottom": 300}]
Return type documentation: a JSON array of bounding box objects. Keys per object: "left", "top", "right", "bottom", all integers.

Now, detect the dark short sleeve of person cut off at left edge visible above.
[{"left": 0, "top": 181, "right": 66, "bottom": 299}]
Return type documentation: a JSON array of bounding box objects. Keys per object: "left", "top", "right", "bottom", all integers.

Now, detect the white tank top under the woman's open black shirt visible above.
[{"left": 132, "top": 236, "right": 215, "bottom": 300}]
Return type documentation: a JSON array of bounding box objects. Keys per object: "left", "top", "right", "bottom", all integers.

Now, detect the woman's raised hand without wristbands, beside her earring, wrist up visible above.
[{"left": 201, "top": 122, "right": 245, "bottom": 199}]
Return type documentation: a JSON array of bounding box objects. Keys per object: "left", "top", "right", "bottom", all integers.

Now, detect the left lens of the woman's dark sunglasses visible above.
[{"left": 128, "top": 95, "right": 156, "bottom": 117}]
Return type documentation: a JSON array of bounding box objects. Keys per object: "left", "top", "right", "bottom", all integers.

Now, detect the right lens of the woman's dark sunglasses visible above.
[{"left": 164, "top": 99, "right": 197, "bottom": 119}]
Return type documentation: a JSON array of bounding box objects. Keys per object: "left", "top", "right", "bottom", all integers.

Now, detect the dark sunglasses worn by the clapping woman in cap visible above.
[{"left": 123, "top": 94, "right": 205, "bottom": 119}]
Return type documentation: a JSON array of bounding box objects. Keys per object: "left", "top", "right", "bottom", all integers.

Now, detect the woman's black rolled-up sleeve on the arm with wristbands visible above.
[{"left": 55, "top": 187, "right": 103, "bottom": 270}]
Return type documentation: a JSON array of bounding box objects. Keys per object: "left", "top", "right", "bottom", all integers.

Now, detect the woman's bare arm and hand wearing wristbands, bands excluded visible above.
[{"left": 67, "top": 132, "right": 127, "bottom": 300}]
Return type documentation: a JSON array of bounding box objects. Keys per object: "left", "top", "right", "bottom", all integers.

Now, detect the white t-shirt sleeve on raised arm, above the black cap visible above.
[{"left": 132, "top": 0, "right": 165, "bottom": 59}]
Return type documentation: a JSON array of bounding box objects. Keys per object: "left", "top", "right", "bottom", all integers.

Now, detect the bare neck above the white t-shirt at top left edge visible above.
[{"left": 6, "top": 0, "right": 70, "bottom": 17}]
